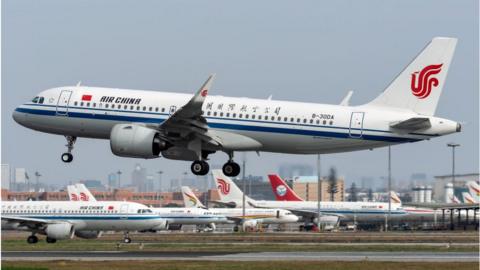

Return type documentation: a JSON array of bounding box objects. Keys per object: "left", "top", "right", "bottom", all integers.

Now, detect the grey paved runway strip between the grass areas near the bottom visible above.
[{"left": 2, "top": 251, "right": 479, "bottom": 262}]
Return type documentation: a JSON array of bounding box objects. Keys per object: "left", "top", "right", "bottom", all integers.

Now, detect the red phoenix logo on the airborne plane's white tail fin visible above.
[{"left": 411, "top": 64, "right": 443, "bottom": 99}]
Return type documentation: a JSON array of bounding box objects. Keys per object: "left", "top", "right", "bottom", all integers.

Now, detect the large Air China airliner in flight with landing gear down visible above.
[{"left": 13, "top": 37, "right": 461, "bottom": 176}]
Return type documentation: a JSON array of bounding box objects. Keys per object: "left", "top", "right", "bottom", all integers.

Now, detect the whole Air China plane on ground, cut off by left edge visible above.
[{"left": 1, "top": 201, "right": 167, "bottom": 244}]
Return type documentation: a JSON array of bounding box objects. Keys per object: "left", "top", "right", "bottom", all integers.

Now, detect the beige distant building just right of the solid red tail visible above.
[{"left": 292, "top": 176, "right": 345, "bottom": 201}]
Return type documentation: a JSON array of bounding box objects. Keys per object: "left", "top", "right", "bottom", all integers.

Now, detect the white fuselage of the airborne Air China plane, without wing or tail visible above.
[{"left": 13, "top": 86, "right": 457, "bottom": 154}]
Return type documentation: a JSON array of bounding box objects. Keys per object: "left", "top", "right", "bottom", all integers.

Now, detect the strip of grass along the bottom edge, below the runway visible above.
[{"left": 2, "top": 261, "right": 478, "bottom": 270}]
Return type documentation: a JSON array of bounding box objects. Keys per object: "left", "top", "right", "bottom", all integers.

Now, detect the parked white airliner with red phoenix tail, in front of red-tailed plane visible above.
[{"left": 212, "top": 170, "right": 407, "bottom": 226}]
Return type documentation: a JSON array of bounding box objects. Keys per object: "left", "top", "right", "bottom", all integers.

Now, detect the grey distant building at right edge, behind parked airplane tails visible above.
[{"left": 433, "top": 173, "right": 479, "bottom": 202}]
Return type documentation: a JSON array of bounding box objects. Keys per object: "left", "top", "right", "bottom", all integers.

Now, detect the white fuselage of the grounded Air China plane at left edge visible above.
[{"left": 2, "top": 201, "right": 165, "bottom": 231}]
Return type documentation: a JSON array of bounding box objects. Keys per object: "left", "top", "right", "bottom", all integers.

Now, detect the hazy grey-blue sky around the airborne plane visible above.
[{"left": 1, "top": 0, "right": 479, "bottom": 188}]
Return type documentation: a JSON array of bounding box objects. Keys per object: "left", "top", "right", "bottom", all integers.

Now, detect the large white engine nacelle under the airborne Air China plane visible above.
[{"left": 110, "top": 124, "right": 170, "bottom": 158}]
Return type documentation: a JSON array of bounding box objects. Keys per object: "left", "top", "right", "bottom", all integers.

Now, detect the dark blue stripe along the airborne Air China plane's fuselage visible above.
[{"left": 16, "top": 108, "right": 421, "bottom": 142}]
